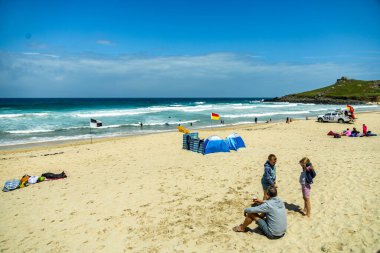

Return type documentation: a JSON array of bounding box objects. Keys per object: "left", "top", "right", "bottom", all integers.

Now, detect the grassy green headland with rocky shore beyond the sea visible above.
[{"left": 265, "top": 76, "right": 380, "bottom": 104}]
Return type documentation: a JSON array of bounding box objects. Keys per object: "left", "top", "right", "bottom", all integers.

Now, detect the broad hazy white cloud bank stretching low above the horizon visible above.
[{"left": 0, "top": 52, "right": 380, "bottom": 97}]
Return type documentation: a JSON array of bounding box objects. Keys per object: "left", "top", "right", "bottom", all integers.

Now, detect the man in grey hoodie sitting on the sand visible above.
[{"left": 233, "top": 186, "right": 287, "bottom": 239}]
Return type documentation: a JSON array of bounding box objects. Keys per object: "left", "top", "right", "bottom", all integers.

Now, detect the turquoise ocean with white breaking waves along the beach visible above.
[{"left": 0, "top": 98, "right": 380, "bottom": 147}]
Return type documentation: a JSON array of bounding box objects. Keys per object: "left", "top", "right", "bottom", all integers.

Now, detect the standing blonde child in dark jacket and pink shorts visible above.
[{"left": 299, "top": 157, "right": 316, "bottom": 217}]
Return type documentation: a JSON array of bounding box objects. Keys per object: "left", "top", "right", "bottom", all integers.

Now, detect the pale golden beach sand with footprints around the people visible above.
[{"left": 0, "top": 112, "right": 380, "bottom": 252}]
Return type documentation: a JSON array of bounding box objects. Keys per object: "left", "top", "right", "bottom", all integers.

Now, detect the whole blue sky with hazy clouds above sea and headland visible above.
[{"left": 0, "top": 0, "right": 380, "bottom": 97}]
